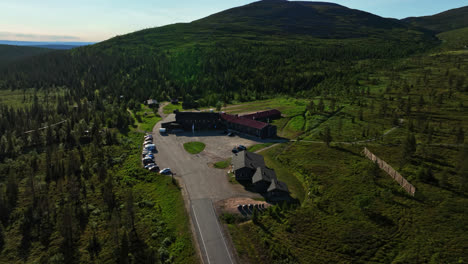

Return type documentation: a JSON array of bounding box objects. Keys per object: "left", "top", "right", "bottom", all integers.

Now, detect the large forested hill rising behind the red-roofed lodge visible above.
[{"left": 0, "top": 1, "right": 438, "bottom": 106}]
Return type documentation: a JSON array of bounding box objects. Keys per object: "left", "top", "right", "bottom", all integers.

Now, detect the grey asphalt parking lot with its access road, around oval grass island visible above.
[{"left": 152, "top": 114, "right": 286, "bottom": 263}]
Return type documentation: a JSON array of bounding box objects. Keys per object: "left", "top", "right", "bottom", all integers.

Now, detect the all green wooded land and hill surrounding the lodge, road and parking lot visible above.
[{"left": 0, "top": 1, "right": 468, "bottom": 263}]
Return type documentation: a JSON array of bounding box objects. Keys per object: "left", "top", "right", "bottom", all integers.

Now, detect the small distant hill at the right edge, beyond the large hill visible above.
[{"left": 402, "top": 6, "right": 468, "bottom": 33}]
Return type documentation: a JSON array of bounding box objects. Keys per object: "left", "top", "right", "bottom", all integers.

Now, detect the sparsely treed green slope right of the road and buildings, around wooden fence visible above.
[{"left": 225, "top": 47, "right": 468, "bottom": 264}]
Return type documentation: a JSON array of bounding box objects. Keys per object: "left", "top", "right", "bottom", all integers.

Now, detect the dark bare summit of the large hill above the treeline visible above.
[{"left": 191, "top": 1, "right": 418, "bottom": 39}]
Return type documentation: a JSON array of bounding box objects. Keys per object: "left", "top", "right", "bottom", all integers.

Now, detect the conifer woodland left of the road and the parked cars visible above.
[{"left": 0, "top": 87, "right": 196, "bottom": 263}]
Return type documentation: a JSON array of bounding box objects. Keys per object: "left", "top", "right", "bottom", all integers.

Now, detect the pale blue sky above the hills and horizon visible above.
[{"left": 0, "top": 0, "right": 468, "bottom": 41}]
